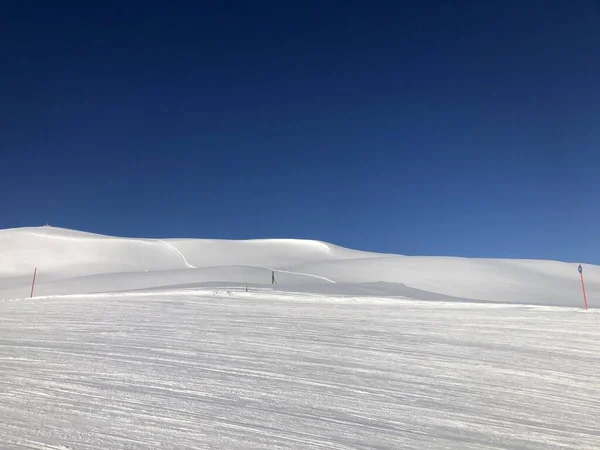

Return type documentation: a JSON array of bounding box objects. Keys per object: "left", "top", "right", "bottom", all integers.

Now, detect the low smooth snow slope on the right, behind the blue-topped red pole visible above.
[{"left": 291, "top": 256, "right": 600, "bottom": 307}]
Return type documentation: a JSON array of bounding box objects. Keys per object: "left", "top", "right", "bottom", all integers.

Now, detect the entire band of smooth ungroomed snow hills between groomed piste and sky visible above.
[{"left": 0, "top": 227, "right": 600, "bottom": 307}]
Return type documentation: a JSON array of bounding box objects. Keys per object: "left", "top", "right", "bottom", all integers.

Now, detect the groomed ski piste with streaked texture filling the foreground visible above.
[{"left": 0, "top": 291, "right": 600, "bottom": 450}]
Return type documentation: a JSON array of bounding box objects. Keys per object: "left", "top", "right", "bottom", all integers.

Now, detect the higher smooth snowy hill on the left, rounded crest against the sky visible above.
[{"left": 0, "top": 227, "right": 369, "bottom": 277}]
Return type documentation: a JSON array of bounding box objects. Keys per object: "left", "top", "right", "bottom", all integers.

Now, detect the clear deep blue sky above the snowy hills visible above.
[{"left": 0, "top": 0, "right": 600, "bottom": 263}]
